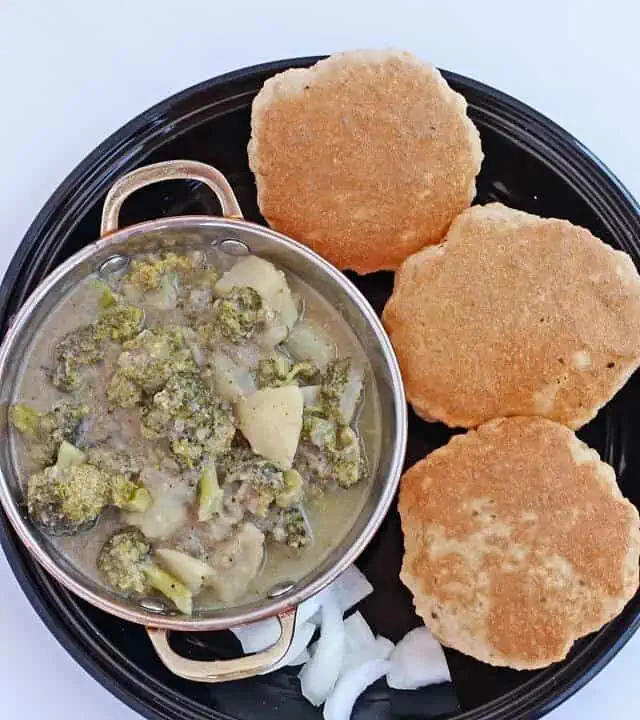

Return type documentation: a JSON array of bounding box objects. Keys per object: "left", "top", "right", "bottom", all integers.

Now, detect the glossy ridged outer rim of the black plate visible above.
[{"left": 0, "top": 56, "right": 640, "bottom": 720}]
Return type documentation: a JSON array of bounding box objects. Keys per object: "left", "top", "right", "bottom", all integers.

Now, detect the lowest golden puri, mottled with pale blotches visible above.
[{"left": 399, "top": 417, "right": 640, "bottom": 669}]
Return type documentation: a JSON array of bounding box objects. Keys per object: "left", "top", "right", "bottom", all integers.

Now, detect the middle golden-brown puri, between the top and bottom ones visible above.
[{"left": 383, "top": 203, "right": 640, "bottom": 429}]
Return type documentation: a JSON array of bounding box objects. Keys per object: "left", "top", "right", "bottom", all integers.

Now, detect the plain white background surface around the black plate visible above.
[{"left": 0, "top": 0, "right": 640, "bottom": 720}]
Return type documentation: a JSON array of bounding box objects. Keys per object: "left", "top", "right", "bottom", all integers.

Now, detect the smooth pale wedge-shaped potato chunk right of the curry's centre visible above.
[{"left": 236, "top": 385, "right": 303, "bottom": 470}]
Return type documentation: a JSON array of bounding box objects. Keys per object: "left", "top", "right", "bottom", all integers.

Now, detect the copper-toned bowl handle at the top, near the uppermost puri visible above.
[{"left": 100, "top": 160, "right": 242, "bottom": 237}]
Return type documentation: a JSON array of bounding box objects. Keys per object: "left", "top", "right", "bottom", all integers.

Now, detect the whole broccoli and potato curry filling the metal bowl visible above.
[{"left": 10, "top": 250, "right": 379, "bottom": 613}]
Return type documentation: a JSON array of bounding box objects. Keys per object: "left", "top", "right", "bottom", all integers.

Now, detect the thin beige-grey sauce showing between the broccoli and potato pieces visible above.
[{"left": 11, "top": 249, "right": 380, "bottom": 609}]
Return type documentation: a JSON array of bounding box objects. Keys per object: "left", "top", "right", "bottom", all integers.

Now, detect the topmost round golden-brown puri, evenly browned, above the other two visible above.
[{"left": 248, "top": 51, "right": 482, "bottom": 273}]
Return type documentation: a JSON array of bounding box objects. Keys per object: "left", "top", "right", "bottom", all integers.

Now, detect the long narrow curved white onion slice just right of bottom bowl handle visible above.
[{"left": 299, "top": 593, "right": 344, "bottom": 707}]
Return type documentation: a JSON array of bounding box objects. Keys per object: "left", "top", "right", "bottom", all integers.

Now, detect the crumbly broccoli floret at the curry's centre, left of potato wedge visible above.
[{"left": 142, "top": 372, "right": 235, "bottom": 468}]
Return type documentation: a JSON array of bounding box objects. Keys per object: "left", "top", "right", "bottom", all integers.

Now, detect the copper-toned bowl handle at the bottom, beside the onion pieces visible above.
[{"left": 146, "top": 608, "right": 297, "bottom": 683}]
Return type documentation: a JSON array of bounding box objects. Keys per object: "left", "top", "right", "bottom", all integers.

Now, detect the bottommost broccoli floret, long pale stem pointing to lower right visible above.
[{"left": 98, "top": 528, "right": 193, "bottom": 615}]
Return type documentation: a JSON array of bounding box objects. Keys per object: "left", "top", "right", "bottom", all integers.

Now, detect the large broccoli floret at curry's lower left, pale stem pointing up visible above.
[{"left": 27, "top": 442, "right": 151, "bottom": 535}]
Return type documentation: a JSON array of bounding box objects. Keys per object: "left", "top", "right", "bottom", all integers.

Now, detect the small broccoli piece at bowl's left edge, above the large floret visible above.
[{"left": 9, "top": 402, "right": 89, "bottom": 465}]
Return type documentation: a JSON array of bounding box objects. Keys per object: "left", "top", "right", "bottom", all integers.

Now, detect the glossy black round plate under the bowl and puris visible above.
[{"left": 0, "top": 58, "right": 640, "bottom": 720}]
